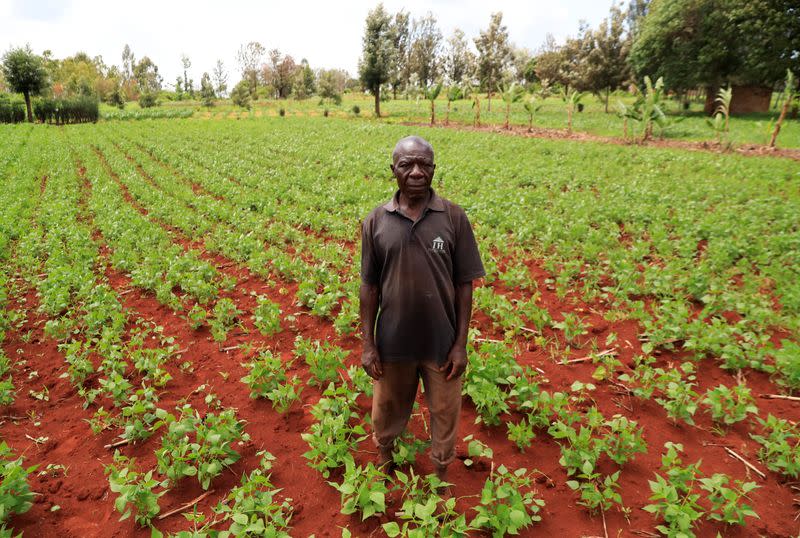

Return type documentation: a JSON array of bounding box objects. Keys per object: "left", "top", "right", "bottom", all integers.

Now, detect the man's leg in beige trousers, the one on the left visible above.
[{"left": 372, "top": 361, "right": 419, "bottom": 464}]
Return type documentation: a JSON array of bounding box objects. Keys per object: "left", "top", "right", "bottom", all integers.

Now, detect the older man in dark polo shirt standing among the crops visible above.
[{"left": 359, "top": 136, "right": 485, "bottom": 481}]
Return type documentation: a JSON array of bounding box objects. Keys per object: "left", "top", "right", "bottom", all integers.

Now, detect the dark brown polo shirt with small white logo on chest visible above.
[{"left": 361, "top": 189, "right": 486, "bottom": 363}]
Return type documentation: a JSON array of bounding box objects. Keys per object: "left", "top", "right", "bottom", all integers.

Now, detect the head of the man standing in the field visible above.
[{"left": 391, "top": 136, "right": 436, "bottom": 199}]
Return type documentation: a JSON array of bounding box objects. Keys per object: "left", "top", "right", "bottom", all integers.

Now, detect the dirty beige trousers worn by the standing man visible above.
[{"left": 372, "top": 361, "right": 462, "bottom": 469}]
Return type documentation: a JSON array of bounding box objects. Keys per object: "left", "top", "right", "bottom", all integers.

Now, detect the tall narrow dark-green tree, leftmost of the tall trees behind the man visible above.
[{"left": 358, "top": 3, "right": 396, "bottom": 117}]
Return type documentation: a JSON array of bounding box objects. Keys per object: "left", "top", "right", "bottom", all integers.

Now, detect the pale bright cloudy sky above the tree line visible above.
[{"left": 0, "top": 0, "right": 618, "bottom": 87}]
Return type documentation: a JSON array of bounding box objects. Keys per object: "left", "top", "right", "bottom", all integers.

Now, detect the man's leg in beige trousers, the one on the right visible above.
[{"left": 420, "top": 361, "right": 462, "bottom": 480}]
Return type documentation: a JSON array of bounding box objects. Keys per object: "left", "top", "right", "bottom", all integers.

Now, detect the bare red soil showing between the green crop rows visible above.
[{"left": 0, "top": 153, "right": 800, "bottom": 537}]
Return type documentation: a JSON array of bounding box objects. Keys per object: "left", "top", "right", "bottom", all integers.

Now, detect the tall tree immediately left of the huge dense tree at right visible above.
[{"left": 583, "top": 5, "right": 630, "bottom": 113}]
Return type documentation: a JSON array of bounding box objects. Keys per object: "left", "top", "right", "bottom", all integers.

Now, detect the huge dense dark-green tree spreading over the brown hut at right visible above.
[{"left": 630, "top": 0, "right": 800, "bottom": 93}]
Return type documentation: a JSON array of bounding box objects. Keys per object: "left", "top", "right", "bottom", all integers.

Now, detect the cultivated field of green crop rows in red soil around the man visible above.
[{"left": 0, "top": 115, "right": 800, "bottom": 537}]
